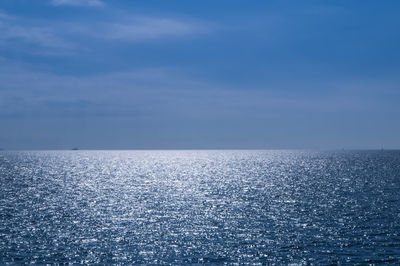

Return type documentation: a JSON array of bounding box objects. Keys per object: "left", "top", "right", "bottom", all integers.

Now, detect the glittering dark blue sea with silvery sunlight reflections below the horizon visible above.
[{"left": 0, "top": 151, "right": 400, "bottom": 265}]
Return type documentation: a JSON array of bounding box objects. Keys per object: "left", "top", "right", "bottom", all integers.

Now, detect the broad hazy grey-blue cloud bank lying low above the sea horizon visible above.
[{"left": 0, "top": 55, "right": 399, "bottom": 148}]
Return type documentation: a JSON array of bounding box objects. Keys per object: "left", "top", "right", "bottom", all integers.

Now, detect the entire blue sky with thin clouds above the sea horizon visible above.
[{"left": 0, "top": 0, "right": 400, "bottom": 149}]
